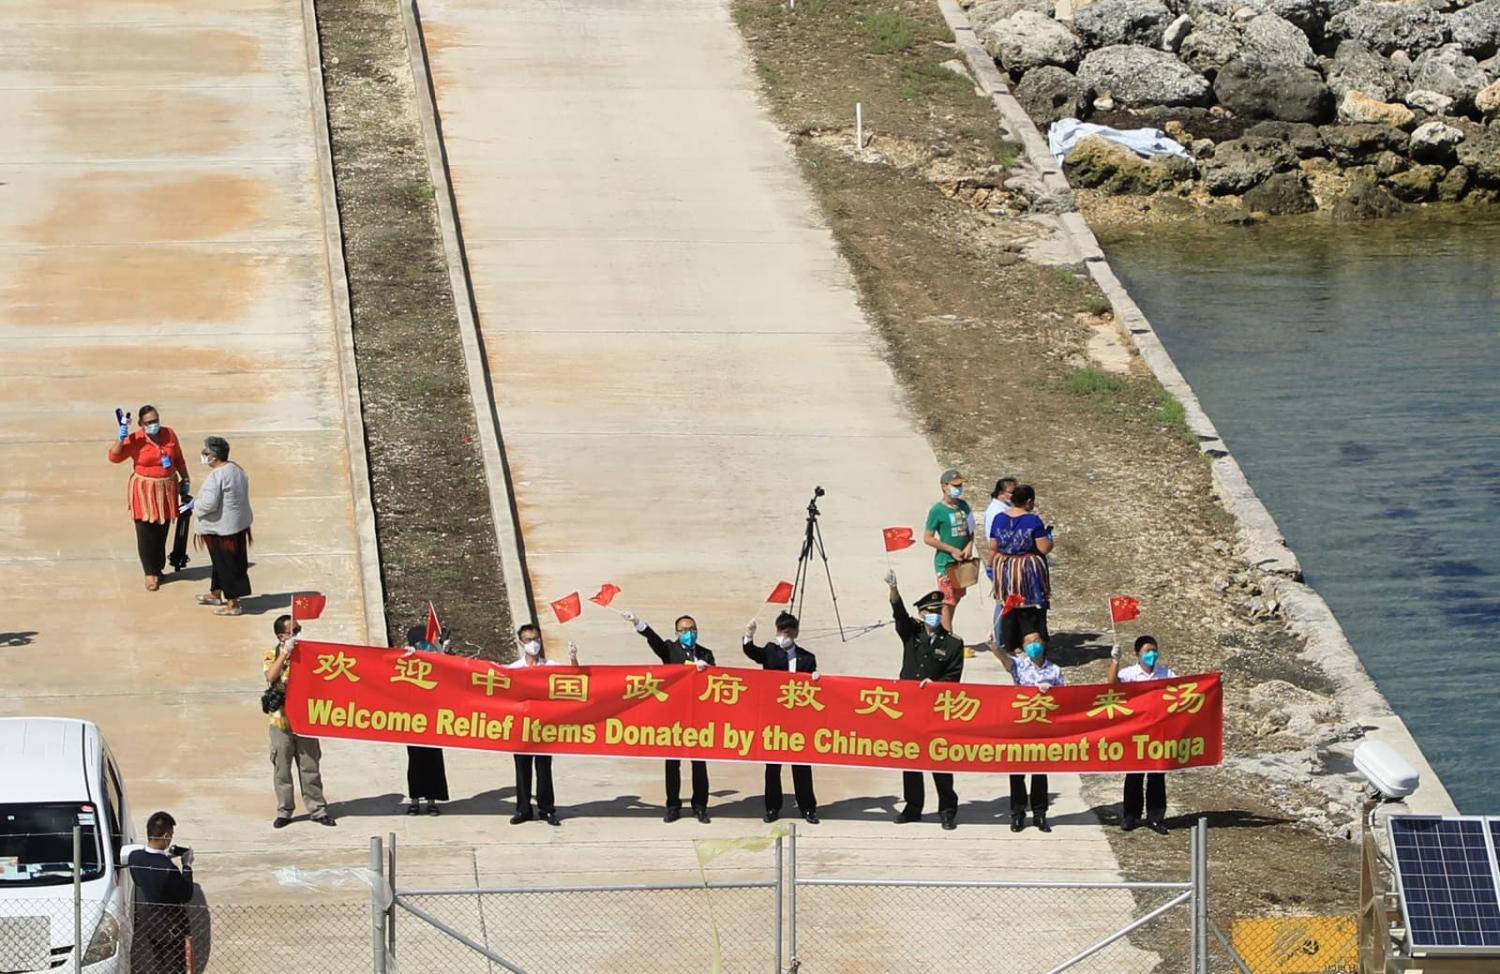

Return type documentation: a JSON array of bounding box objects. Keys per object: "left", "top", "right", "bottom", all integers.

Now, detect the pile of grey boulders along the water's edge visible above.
[{"left": 968, "top": 0, "right": 1500, "bottom": 222}]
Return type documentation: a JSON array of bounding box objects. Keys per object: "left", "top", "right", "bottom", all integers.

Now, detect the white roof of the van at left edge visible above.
[{"left": 0, "top": 717, "right": 104, "bottom": 804}]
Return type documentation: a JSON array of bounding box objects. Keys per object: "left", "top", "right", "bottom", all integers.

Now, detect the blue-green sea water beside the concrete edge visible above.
[{"left": 1104, "top": 210, "right": 1500, "bottom": 813}]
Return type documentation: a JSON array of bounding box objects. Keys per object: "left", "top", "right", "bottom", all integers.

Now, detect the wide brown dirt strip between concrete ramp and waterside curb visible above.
[{"left": 734, "top": 0, "right": 1358, "bottom": 947}]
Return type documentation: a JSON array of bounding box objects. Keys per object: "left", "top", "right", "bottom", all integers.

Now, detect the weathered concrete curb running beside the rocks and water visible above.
[{"left": 938, "top": 0, "right": 1457, "bottom": 815}]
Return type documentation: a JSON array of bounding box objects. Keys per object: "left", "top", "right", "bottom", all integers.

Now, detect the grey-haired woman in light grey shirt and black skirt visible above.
[{"left": 194, "top": 437, "right": 255, "bottom": 615}]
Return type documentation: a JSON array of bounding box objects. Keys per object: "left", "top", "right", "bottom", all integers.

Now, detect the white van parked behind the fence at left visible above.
[{"left": 0, "top": 717, "right": 135, "bottom": 974}]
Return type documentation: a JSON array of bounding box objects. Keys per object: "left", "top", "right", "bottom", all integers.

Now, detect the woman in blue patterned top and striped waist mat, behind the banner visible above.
[{"left": 990, "top": 483, "right": 1052, "bottom": 654}]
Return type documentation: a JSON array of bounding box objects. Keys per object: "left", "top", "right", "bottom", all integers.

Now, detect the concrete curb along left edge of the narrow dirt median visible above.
[{"left": 302, "top": 0, "right": 390, "bottom": 645}]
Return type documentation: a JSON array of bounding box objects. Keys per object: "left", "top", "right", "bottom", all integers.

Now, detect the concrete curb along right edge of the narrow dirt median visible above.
[{"left": 401, "top": 0, "right": 537, "bottom": 626}]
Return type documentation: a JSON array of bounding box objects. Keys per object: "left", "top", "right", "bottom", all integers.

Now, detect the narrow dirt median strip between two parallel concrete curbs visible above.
[{"left": 317, "top": 0, "right": 512, "bottom": 657}]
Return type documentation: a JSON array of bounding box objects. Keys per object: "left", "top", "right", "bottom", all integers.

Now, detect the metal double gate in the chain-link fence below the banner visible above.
[{"left": 371, "top": 821, "right": 1248, "bottom": 974}]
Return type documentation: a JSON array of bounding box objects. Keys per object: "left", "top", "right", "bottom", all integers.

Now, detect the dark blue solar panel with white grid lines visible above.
[{"left": 1388, "top": 815, "right": 1500, "bottom": 956}]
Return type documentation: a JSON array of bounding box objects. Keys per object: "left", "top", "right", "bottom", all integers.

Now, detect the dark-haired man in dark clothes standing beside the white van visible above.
[{"left": 126, "top": 812, "right": 192, "bottom": 974}]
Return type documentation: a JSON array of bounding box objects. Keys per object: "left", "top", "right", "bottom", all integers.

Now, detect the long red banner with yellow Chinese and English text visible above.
[{"left": 285, "top": 639, "right": 1224, "bottom": 771}]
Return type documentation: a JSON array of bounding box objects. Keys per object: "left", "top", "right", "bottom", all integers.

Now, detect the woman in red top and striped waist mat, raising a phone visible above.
[{"left": 110, "top": 405, "right": 189, "bottom": 591}]
